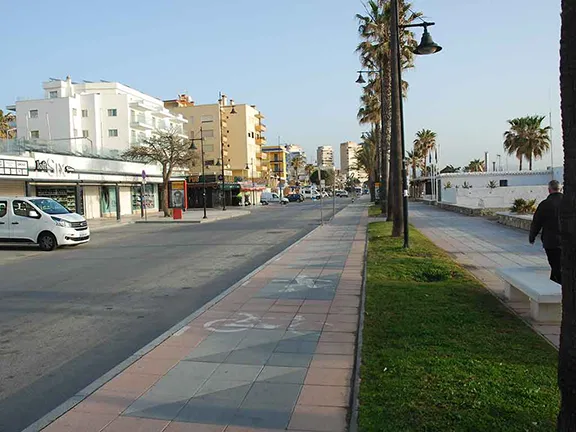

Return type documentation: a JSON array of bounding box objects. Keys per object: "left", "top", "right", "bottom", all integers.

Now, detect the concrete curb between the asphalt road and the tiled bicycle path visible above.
[{"left": 22, "top": 213, "right": 326, "bottom": 432}]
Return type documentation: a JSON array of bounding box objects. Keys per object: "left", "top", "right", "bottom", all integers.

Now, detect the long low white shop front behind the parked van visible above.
[{"left": 0, "top": 153, "right": 162, "bottom": 219}]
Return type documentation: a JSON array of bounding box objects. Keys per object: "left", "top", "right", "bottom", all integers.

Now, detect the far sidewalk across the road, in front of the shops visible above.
[{"left": 88, "top": 207, "right": 251, "bottom": 231}]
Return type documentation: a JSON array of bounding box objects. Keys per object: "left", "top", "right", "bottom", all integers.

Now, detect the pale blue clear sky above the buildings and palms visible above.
[{"left": 0, "top": 0, "right": 562, "bottom": 169}]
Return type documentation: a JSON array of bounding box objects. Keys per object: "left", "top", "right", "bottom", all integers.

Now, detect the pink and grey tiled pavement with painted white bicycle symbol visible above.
[{"left": 44, "top": 204, "right": 367, "bottom": 432}]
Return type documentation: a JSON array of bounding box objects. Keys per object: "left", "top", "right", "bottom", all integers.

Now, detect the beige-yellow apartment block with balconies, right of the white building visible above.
[{"left": 164, "top": 94, "right": 268, "bottom": 183}]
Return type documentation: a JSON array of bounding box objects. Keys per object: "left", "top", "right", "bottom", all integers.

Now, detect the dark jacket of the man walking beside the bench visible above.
[{"left": 530, "top": 192, "right": 562, "bottom": 249}]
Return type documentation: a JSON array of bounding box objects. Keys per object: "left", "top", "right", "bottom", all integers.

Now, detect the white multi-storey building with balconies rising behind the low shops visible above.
[{"left": 8, "top": 77, "right": 187, "bottom": 155}]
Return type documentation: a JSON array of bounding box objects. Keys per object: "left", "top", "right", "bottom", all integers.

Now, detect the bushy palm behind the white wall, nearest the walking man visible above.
[{"left": 504, "top": 115, "right": 550, "bottom": 171}]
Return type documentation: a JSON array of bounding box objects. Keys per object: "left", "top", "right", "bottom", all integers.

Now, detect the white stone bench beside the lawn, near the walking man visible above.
[{"left": 497, "top": 267, "right": 562, "bottom": 322}]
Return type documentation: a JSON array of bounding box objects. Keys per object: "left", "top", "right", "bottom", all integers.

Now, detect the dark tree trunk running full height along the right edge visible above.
[{"left": 557, "top": 0, "right": 576, "bottom": 432}]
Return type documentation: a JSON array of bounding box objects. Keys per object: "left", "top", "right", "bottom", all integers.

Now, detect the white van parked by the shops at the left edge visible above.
[{"left": 0, "top": 197, "right": 90, "bottom": 251}]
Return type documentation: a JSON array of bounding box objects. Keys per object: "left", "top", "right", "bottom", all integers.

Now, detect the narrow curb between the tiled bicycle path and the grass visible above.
[{"left": 348, "top": 211, "right": 370, "bottom": 432}]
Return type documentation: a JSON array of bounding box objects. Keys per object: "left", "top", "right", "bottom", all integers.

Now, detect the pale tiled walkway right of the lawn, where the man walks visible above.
[{"left": 410, "top": 204, "right": 560, "bottom": 347}]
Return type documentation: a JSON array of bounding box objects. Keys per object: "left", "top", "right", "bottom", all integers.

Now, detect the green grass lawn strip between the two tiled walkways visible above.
[{"left": 360, "top": 222, "right": 559, "bottom": 432}]
